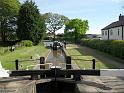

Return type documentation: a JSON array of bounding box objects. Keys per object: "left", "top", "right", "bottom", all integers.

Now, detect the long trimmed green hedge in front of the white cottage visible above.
[{"left": 81, "top": 39, "right": 124, "bottom": 59}]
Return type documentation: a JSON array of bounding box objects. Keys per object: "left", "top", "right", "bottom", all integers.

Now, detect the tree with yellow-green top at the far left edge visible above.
[{"left": 0, "top": 0, "right": 20, "bottom": 41}]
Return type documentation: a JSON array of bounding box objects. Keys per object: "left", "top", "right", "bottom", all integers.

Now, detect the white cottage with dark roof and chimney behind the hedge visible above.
[{"left": 101, "top": 14, "right": 124, "bottom": 40}]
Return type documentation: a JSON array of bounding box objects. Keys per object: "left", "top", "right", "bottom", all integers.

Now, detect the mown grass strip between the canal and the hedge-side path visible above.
[{"left": 67, "top": 45, "right": 116, "bottom": 69}]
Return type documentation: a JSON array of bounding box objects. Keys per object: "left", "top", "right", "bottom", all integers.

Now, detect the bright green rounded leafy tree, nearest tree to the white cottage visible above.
[{"left": 65, "top": 19, "right": 89, "bottom": 43}]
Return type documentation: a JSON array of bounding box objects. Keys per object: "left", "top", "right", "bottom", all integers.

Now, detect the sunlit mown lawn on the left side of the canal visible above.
[{"left": 0, "top": 45, "right": 49, "bottom": 70}]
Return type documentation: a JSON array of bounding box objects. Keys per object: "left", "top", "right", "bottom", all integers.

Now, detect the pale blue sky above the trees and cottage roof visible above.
[{"left": 20, "top": 0, "right": 124, "bottom": 34}]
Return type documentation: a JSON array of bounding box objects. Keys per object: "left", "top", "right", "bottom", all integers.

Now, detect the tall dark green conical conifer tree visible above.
[{"left": 17, "top": 0, "right": 46, "bottom": 44}]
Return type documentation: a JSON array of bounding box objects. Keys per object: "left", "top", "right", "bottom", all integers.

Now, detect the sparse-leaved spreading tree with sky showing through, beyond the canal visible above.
[{"left": 43, "top": 13, "right": 68, "bottom": 40}]
